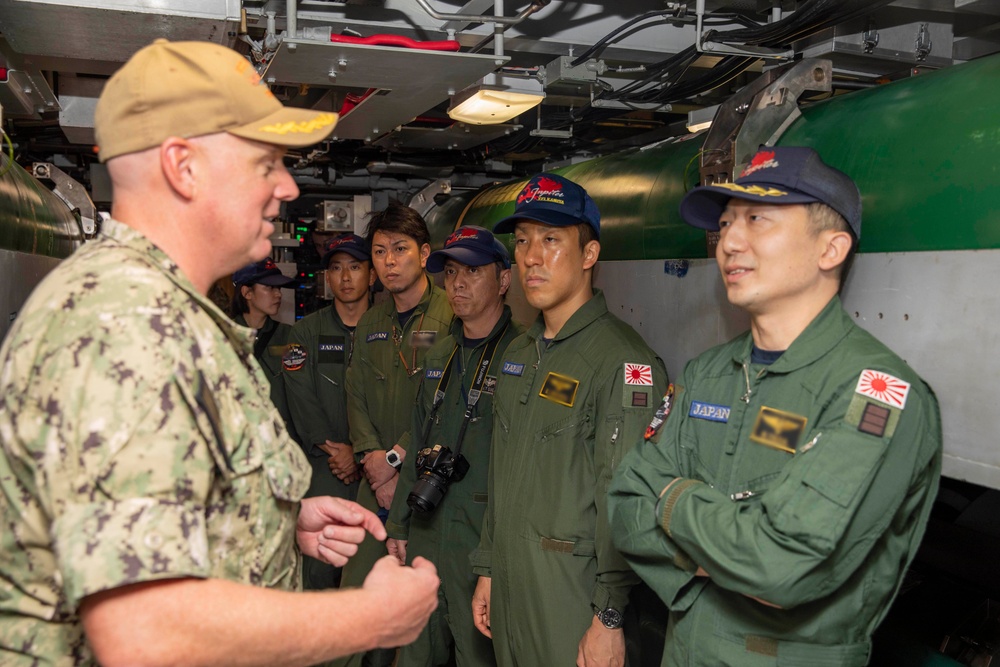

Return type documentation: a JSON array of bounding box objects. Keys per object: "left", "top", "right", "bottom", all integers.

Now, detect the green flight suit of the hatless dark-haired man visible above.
[{"left": 338, "top": 278, "right": 454, "bottom": 665}]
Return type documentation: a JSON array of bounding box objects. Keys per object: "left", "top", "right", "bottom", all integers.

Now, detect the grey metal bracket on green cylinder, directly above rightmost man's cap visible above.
[{"left": 700, "top": 58, "right": 833, "bottom": 185}]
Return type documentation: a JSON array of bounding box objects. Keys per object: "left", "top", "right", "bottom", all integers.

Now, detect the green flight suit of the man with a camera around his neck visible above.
[{"left": 386, "top": 306, "right": 524, "bottom": 667}]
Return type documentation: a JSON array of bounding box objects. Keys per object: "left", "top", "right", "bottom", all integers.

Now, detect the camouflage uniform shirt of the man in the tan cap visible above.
[{"left": 0, "top": 220, "right": 309, "bottom": 665}]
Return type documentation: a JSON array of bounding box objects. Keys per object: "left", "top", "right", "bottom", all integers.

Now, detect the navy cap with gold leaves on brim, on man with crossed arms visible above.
[{"left": 680, "top": 146, "right": 861, "bottom": 239}]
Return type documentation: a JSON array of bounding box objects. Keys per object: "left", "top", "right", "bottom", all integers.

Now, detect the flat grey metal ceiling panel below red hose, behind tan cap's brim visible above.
[{"left": 264, "top": 39, "right": 507, "bottom": 141}]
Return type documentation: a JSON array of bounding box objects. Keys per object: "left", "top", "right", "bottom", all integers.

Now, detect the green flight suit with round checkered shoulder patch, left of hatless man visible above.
[{"left": 282, "top": 305, "right": 358, "bottom": 590}]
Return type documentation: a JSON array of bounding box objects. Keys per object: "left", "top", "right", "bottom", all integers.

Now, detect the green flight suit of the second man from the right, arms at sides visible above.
[{"left": 473, "top": 290, "right": 666, "bottom": 667}]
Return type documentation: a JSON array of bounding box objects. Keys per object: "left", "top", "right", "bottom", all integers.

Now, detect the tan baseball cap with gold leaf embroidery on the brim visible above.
[{"left": 94, "top": 39, "right": 337, "bottom": 162}]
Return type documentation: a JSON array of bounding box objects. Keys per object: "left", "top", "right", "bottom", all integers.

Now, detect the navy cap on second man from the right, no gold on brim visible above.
[{"left": 493, "top": 174, "right": 601, "bottom": 238}]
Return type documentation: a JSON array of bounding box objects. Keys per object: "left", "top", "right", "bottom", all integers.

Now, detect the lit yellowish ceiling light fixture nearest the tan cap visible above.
[{"left": 448, "top": 74, "right": 545, "bottom": 125}]
